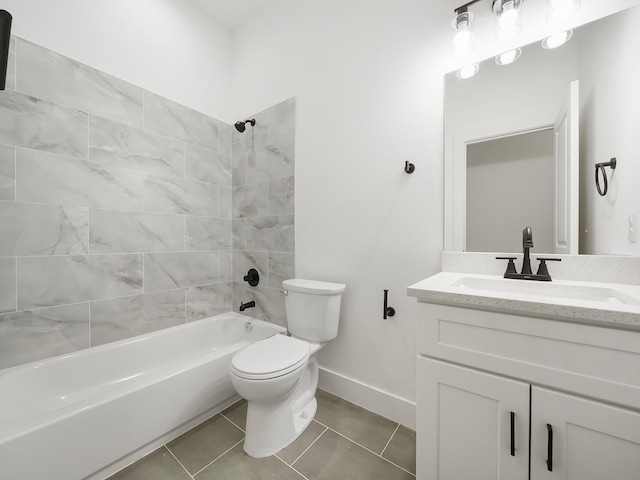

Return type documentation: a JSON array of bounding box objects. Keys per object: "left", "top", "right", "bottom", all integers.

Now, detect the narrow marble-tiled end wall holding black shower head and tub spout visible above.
[{"left": 232, "top": 98, "right": 295, "bottom": 326}]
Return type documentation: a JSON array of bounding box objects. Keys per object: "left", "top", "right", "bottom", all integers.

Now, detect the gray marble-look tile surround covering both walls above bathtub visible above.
[{"left": 0, "top": 37, "right": 295, "bottom": 368}]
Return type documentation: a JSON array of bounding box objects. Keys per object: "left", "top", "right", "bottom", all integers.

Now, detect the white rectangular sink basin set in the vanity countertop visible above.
[{"left": 451, "top": 276, "right": 640, "bottom": 305}]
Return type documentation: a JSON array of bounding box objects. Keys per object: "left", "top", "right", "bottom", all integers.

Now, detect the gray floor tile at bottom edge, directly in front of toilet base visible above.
[{"left": 195, "top": 445, "right": 304, "bottom": 480}]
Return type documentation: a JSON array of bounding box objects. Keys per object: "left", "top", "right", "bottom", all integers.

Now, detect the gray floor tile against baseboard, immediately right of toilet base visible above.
[{"left": 315, "top": 390, "right": 398, "bottom": 454}]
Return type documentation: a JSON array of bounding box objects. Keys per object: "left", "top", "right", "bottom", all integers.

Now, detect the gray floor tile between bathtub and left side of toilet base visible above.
[{"left": 167, "top": 415, "right": 244, "bottom": 475}]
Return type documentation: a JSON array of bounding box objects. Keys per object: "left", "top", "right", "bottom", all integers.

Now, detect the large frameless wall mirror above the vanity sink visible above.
[{"left": 444, "top": 7, "right": 640, "bottom": 255}]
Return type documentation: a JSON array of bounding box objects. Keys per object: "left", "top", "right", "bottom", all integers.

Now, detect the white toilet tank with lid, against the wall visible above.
[{"left": 282, "top": 278, "right": 346, "bottom": 342}]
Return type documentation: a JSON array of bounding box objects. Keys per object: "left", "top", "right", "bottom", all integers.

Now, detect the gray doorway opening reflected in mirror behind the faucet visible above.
[{"left": 466, "top": 128, "right": 555, "bottom": 252}]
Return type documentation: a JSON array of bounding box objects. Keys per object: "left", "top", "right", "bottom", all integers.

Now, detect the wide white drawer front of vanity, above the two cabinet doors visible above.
[{"left": 417, "top": 302, "right": 640, "bottom": 409}]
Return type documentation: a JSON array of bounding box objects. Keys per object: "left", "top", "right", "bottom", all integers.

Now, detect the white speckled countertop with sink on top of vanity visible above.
[{"left": 407, "top": 272, "right": 640, "bottom": 329}]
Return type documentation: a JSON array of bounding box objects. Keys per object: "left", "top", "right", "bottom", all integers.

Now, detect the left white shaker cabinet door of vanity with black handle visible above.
[{"left": 416, "top": 357, "right": 530, "bottom": 480}]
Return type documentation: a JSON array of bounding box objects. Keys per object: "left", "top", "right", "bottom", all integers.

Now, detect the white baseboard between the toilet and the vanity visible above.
[{"left": 318, "top": 367, "right": 416, "bottom": 430}]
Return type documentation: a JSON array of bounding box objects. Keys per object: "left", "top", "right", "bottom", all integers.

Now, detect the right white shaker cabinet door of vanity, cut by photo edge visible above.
[{"left": 531, "top": 387, "right": 640, "bottom": 480}]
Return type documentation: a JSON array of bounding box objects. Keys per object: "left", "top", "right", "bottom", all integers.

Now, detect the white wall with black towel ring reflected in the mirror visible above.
[{"left": 579, "top": 8, "right": 640, "bottom": 255}]
